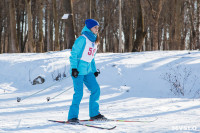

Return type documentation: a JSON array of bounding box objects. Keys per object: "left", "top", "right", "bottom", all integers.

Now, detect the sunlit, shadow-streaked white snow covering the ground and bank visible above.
[{"left": 0, "top": 50, "right": 200, "bottom": 133}]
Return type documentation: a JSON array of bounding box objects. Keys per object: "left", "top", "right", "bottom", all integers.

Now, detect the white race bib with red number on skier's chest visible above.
[{"left": 81, "top": 35, "right": 97, "bottom": 62}]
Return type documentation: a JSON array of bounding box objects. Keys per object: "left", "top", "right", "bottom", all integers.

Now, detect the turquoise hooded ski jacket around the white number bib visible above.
[{"left": 69, "top": 26, "right": 97, "bottom": 75}]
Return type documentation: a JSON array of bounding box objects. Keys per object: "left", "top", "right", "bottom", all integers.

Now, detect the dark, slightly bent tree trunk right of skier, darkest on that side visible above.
[{"left": 132, "top": 0, "right": 146, "bottom": 52}]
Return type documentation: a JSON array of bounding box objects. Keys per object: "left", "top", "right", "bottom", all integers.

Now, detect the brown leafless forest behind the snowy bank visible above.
[{"left": 0, "top": 0, "right": 200, "bottom": 53}]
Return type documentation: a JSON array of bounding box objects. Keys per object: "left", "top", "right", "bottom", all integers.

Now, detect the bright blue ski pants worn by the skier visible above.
[{"left": 68, "top": 73, "right": 100, "bottom": 120}]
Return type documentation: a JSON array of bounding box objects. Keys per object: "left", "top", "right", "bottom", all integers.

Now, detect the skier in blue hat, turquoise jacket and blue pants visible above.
[{"left": 68, "top": 19, "right": 107, "bottom": 123}]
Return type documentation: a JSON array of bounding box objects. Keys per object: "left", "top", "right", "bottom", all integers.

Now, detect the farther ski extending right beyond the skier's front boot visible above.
[{"left": 79, "top": 118, "right": 158, "bottom": 123}]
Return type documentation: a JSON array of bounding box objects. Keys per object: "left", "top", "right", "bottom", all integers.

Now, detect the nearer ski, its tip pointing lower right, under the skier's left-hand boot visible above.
[{"left": 48, "top": 120, "right": 116, "bottom": 130}]
